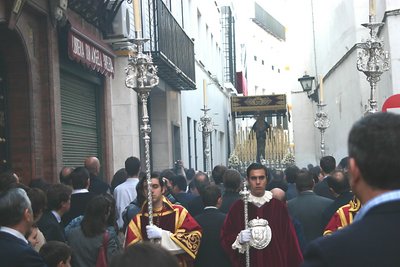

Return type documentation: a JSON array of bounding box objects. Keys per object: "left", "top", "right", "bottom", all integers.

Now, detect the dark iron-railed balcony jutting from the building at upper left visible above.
[{"left": 147, "top": 0, "right": 196, "bottom": 90}]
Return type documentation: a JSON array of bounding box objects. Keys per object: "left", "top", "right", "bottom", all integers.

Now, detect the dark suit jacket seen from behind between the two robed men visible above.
[{"left": 194, "top": 208, "right": 231, "bottom": 267}]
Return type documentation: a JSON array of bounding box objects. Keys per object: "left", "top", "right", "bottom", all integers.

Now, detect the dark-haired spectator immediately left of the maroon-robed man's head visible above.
[{"left": 219, "top": 169, "right": 242, "bottom": 213}]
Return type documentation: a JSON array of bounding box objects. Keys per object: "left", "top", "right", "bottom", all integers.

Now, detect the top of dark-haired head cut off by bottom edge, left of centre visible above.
[{"left": 110, "top": 242, "right": 179, "bottom": 267}]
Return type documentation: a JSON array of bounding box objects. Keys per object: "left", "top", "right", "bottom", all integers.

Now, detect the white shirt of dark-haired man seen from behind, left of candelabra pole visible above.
[{"left": 114, "top": 177, "right": 139, "bottom": 229}]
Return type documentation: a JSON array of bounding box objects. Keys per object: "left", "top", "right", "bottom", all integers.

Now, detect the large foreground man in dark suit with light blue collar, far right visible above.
[{"left": 304, "top": 112, "right": 400, "bottom": 267}]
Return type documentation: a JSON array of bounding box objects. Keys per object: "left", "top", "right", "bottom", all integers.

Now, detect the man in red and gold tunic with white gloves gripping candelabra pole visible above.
[{"left": 125, "top": 177, "right": 201, "bottom": 266}]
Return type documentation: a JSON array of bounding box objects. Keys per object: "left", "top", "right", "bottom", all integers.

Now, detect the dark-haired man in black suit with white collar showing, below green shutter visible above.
[{"left": 61, "top": 167, "right": 96, "bottom": 227}]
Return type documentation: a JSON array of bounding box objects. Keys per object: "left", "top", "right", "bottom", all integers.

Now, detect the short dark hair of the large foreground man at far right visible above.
[{"left": 348, "top": 112, "right": 400, "bottom": 189}]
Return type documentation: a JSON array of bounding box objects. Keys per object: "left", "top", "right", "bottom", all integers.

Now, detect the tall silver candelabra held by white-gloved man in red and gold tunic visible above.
[{"left": 125, "top": 32, "right": 159, "bottom": 225}]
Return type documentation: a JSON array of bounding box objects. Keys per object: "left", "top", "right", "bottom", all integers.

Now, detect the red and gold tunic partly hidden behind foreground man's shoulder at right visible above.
[{"left": 324, "top": 197, "right": 361, "bottom": 235}]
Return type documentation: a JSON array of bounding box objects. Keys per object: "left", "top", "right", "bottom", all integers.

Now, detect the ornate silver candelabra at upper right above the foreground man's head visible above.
[{"left": 357, "top": 11, "right": 390, "bottom": 115}]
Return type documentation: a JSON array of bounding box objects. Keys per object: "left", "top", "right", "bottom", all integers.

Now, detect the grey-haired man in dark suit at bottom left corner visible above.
[{"left": 0, "top": 188, "right": 46, "bottom": 267}]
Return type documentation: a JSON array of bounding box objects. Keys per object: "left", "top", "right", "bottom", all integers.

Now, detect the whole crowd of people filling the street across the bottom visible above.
[{"left": 0, "top": 113, "right": 400, "bottom": 267}]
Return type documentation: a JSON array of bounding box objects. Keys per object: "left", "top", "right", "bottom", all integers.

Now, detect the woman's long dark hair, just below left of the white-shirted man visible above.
[{"left": 81, "top": 195, "right": 115, "bottom": 237}]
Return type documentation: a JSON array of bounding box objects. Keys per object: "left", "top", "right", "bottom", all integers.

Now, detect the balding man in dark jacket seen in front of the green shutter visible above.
[{"left": 85, "top": 157, "right": 111, "bottom": 195}]
